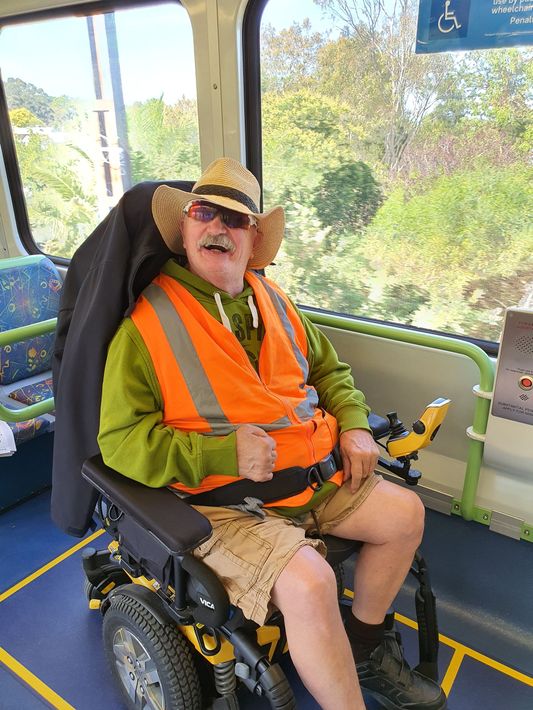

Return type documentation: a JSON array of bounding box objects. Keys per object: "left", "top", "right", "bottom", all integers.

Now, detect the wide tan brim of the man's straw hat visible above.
[{"left": 152, "top": 185, "right": 285, "bottom": 269}]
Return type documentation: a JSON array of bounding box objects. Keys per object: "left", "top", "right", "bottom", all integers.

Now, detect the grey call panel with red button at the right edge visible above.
[{"left": 492, "top": 308, "right": 533, "bottom": 424}]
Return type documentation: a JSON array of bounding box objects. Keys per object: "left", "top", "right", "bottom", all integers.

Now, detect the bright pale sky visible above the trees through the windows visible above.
[{"left": 0, "top": 0, "right": 328, "bottom": 104}]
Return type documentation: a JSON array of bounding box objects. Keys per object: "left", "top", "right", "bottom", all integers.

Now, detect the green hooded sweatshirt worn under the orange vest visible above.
[{"left": 98, "top": 259, "right": 369, "bottom": 516}]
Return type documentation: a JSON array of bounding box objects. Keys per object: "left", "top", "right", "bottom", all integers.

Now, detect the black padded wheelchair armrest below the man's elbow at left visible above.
[{"left": 82, "top": 455, "right": 212, "bottom": 555}]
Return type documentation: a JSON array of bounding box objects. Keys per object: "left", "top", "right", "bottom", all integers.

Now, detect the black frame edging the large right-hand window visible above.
[{"left": 242, "top": 0, "right": 500, "bottom": 357}]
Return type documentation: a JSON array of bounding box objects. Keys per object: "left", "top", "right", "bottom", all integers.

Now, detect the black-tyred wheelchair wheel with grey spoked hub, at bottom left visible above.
[{"left": 103, "top": 594, "right": 202, "bottom": 710}]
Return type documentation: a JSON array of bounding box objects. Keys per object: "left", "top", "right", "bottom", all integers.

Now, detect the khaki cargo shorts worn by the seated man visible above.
[{"left": 194, "top": 474, "right": 381, "bottom": 625}]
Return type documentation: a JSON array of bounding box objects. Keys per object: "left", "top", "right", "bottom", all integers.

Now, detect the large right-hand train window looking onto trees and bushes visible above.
[{"left": 260, "top": 0, "right": 533, "bottom": 341}]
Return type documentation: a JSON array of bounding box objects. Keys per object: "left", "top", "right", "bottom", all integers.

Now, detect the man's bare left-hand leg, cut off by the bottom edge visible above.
[{"left": 272, "top": 546, "right": 365, "bottom": 710}]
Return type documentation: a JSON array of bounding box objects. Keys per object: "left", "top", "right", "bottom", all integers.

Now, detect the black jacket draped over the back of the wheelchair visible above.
[{"left": 52, "top": 181, "right": 193, "bottom": 537}]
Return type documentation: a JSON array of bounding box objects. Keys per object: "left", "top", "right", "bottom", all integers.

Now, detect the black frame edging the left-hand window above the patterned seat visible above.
[{"left": 0, "top": 0, "right": 183, "bottom": 266}]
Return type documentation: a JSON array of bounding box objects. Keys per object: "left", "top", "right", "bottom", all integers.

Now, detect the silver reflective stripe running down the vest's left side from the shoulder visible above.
[{"left": 143, "top": 284, "right": 291, "bottom": 436}]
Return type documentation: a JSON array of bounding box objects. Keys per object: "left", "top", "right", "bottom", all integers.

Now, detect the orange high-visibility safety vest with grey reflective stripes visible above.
[{"left": 131, "top": 271, "right": 342, "bottom": 507}]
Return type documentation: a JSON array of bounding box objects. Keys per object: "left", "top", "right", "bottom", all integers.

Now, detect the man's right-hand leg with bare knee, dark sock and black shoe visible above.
[{"left": 330, "top": 481, "right": 446, "bottom": 710}]
